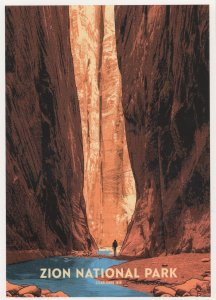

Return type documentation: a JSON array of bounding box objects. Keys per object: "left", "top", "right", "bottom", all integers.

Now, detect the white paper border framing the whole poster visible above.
[{"left": 0, "top": 0, "right": 216, "bottom": 300}]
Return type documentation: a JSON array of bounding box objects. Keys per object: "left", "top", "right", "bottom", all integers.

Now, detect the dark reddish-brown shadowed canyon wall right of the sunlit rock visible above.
[{"left": 115, "top": 6, "right": 210, "bottom": 257}]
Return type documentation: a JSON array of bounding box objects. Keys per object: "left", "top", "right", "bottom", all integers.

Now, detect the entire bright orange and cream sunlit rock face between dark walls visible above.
[{"left": 70, "top": 6, "right": 135, "bottom": 246}]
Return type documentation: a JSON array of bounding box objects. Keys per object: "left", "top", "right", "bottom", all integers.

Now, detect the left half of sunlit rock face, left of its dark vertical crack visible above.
[{"left": 70, "top": 6, "right": 101, "bottom": 246}]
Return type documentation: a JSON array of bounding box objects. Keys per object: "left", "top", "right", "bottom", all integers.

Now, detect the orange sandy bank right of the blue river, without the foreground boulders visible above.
[{"left": 100, "top": 253, "right": 210, "bottom": 296}]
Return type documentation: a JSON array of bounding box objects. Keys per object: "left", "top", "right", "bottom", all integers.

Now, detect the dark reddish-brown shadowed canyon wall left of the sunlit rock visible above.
[{"left": 6, "top": 6, "right": 96, "bottom": 262}]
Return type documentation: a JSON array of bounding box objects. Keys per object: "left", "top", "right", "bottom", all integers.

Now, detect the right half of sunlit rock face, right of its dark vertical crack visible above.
[{"left": 100, "top": 6, "right": 136, "bottom": 245}]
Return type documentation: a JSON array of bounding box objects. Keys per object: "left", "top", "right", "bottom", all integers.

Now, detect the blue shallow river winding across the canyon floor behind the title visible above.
[{"left": 7, "top": 253, "right": 149, "bottom": 297}]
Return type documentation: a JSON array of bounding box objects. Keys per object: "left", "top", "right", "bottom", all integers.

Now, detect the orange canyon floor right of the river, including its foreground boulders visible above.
[{"left": 100, "top": 253, "right": 211, "bottom": 297}]
